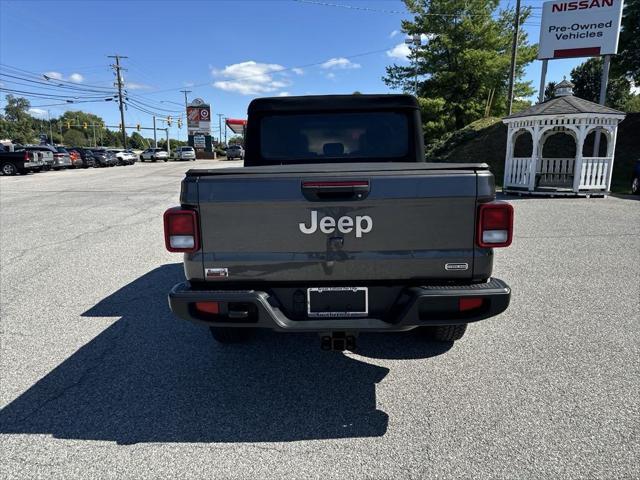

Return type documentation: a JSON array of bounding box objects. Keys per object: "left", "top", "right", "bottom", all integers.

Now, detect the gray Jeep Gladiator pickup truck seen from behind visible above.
[{"left": 164, "top": 95, "right": 513, "bottom": 350}]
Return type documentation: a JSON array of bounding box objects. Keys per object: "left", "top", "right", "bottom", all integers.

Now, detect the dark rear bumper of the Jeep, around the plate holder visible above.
[{"left": 169, "top": 278, "right": 511, "bottom": 332}]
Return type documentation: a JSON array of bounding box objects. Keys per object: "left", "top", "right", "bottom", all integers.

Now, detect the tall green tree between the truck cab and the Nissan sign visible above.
[{"left": 383, "top": 0, "right": 537, "bottom": 143}]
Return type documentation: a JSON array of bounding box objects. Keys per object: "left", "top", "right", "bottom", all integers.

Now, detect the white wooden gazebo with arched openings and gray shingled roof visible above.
[{"left": 502, "top": 80, "right": 625, "bottom": 196}]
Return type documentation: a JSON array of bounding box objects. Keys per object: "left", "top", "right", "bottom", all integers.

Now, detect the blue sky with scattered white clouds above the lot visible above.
[{"left": 0, "top": 0, "right": 581, "bottom": 138}]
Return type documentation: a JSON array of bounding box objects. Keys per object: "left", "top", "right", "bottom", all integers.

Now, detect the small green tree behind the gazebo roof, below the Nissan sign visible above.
[{"left": 571, "top": 57, "right": 632, "bottom": 110}]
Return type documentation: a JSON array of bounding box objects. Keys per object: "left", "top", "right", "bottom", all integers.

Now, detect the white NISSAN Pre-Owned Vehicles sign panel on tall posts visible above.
[{"left": 538, "top": 0, "right": 623, "bottom": 60}]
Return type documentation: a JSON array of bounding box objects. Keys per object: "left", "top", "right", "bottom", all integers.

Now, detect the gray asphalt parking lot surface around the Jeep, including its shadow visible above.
[{"left": 0, "top": 161, "right": 640, "bottom": 479}]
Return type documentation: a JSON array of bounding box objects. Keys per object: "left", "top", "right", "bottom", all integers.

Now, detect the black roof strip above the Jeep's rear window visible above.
[{"left": 249, "top": 94, "right": 418, "bottom": 116}]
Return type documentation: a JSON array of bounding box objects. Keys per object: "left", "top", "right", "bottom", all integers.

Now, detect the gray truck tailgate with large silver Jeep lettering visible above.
[{"left": 190, "top": 164, "right": 484, "bottom": 283}]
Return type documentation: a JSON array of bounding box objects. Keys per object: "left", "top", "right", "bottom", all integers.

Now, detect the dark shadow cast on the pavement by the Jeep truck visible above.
[{"left": 0, "top": 264, "right": 450, "bottom": 444}]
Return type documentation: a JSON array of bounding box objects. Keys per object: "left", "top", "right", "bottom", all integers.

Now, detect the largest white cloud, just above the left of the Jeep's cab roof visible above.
[{"left": 211, "top": 60, "right": 291, "bottom": 95}]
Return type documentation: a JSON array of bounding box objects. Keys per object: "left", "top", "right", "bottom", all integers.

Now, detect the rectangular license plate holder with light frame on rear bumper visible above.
[{"left": 307, "top": 287, "right": 369, "bottom": 318}]
